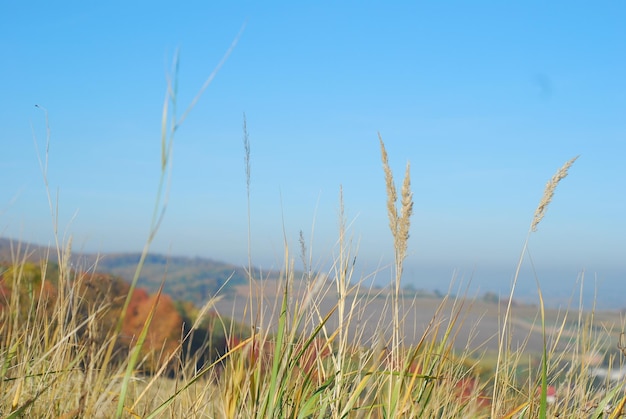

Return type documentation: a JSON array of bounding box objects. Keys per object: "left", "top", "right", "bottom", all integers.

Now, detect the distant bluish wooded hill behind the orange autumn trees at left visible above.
[{"left": 0, "top": 238, "right": 278, "bottom": 305}]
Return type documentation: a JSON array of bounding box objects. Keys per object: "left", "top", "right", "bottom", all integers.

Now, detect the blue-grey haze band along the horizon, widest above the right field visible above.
[{"left": 0, "top": 237, "right": 626, "bottom": 310}]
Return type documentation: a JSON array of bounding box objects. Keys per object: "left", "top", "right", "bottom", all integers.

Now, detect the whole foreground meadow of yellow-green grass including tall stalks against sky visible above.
[{"left": 0, "top": 58, "right": 626, "bottom": 418}]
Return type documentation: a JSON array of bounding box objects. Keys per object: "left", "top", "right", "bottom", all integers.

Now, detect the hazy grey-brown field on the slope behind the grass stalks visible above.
[{"left": 215, "top": 280, "right": 621, "bottom": 355}]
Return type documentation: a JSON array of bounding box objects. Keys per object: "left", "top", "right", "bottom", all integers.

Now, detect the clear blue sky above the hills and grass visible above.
[{"left": 0, "top": 1, "right": 626, "bottom": 306}]
